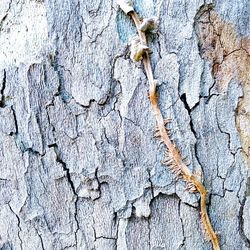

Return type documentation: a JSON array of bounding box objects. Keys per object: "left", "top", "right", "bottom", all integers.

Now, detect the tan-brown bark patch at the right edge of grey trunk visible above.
[{"left": 196, "top": 5, "right": 250, "bottom": 165}]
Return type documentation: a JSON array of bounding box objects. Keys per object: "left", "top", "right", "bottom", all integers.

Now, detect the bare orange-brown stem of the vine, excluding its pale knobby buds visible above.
[{"left": 128, "top": 11, "right": 220, "bottom": 250}]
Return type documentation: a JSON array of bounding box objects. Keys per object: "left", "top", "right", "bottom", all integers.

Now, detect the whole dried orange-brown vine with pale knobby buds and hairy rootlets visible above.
[{"left": 118, "top": 0, "right": 220, "bottom": 250}]
